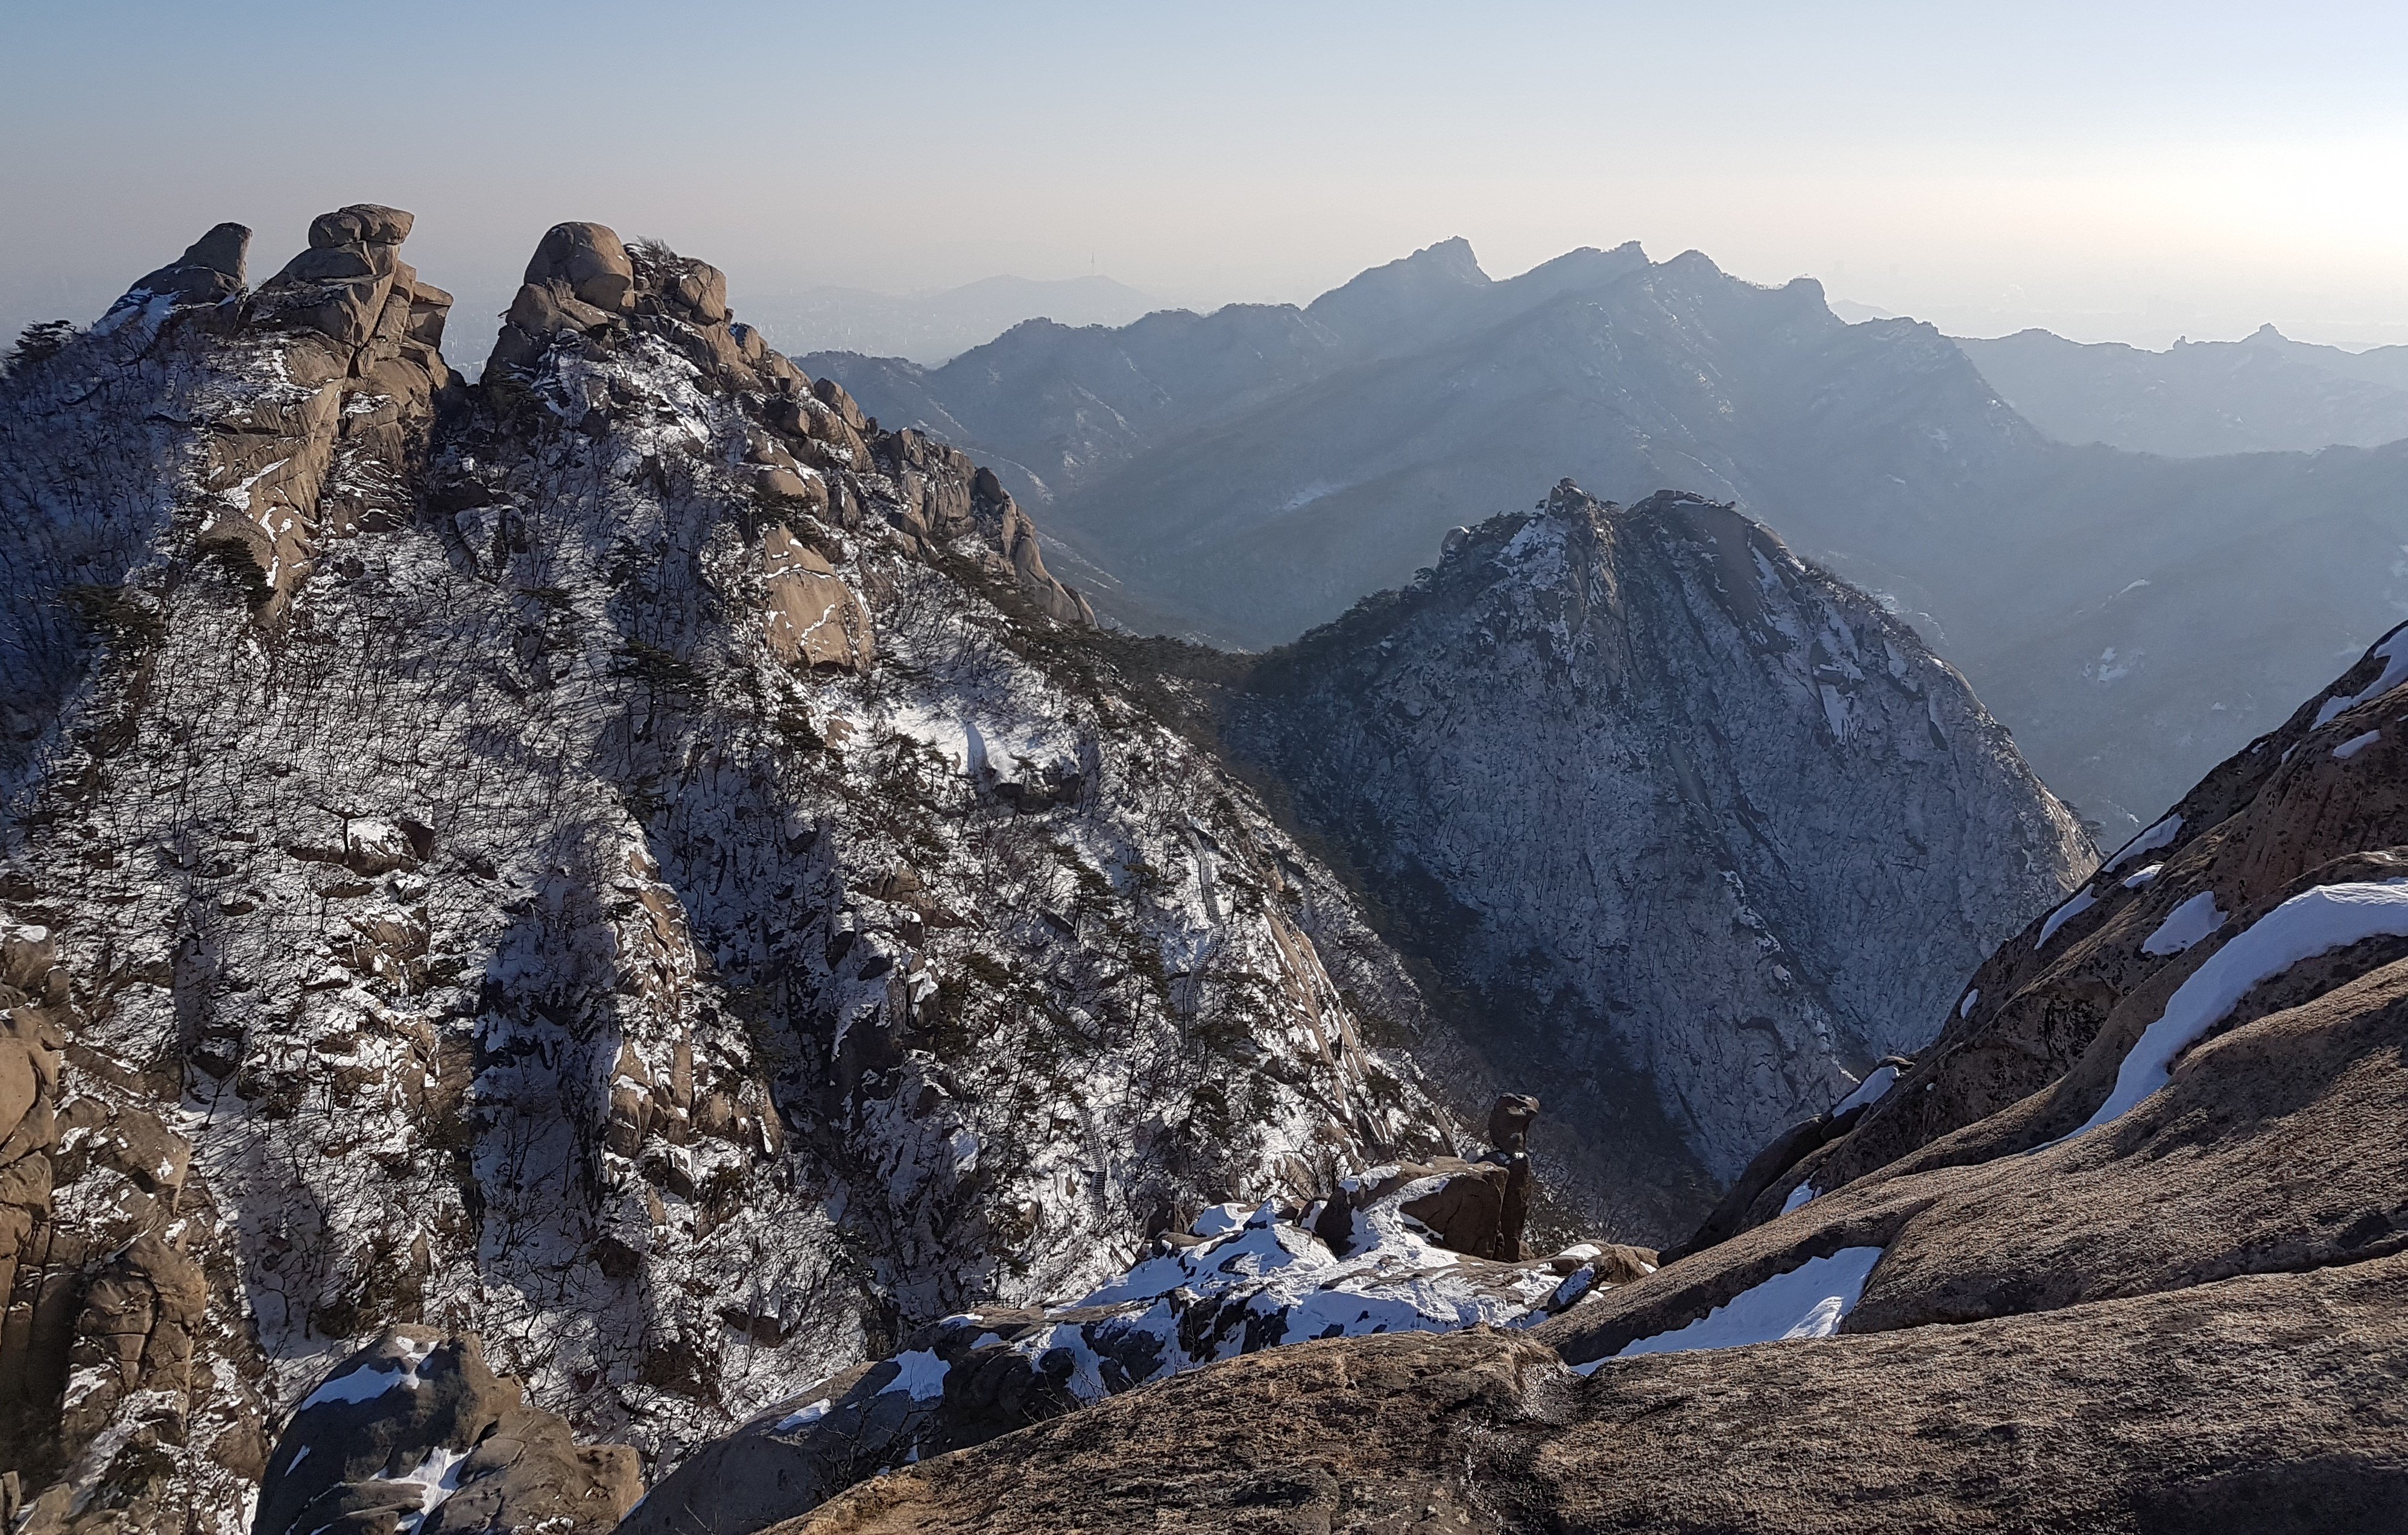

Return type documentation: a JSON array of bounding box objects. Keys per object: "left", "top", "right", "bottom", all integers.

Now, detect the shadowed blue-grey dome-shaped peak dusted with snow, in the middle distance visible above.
[{"left": 1230, "top": 482, "right": 2090, "bottom": 1204}]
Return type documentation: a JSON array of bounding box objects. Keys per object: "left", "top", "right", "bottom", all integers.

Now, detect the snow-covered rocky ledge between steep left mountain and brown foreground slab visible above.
[{"left": 621, "top": 1099, "right": 1654, "bottom": 1535}]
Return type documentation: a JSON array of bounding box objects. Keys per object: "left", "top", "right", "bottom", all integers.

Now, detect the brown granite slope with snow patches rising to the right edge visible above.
[{"left": 780, "top": 629, "right": 2408, "bottom": 1535}]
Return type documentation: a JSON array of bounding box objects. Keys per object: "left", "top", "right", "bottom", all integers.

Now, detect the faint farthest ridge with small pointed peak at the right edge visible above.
[{"left": 1958, "top": 325, "right": 2408, "bottom": 458}]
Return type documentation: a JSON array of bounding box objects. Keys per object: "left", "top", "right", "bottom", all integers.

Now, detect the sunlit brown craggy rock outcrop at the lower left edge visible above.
[{"left": 0, "top": 918, "right": 272, "bottom": 1535}]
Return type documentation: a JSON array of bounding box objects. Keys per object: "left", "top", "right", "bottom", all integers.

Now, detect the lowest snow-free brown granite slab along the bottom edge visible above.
[{"left": 776, "top": 1258, "right": 2408, "bottom": 1535}]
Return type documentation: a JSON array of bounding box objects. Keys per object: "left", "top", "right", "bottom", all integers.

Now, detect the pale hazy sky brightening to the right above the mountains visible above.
[{"left": 14, "top": 0, "right": 2408, "bottom": 344}]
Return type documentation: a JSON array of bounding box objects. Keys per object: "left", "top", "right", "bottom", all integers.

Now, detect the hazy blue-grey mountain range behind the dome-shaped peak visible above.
[{"left": 804, "top": 241, "right": 2408, "bottom": 836}]
